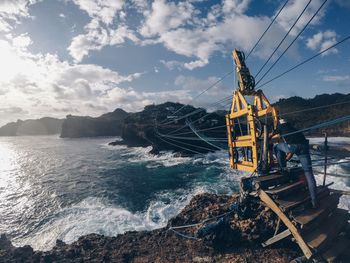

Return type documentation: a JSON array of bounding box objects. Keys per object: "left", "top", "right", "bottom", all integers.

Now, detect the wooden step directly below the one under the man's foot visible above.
[{"left": 302, "top": 208, "right": 349, "bottom": 250}]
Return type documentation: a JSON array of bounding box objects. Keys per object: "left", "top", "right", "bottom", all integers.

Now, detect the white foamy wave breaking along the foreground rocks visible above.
[{"left": 13, "top": 187, "right": 213, "bottom": 251}]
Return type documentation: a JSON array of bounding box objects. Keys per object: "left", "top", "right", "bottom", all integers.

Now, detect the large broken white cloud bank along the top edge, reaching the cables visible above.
[{"left": 68, "top": 0, "right": 325, "bottom": 70}]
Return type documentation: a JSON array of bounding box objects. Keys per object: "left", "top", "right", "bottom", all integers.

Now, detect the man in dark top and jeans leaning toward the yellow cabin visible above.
[{"left": 270, "top": 119, "right": 317, "bottom": 208}]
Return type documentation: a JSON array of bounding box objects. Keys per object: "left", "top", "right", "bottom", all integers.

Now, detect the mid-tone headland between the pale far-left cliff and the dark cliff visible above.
[{"left": 61, "top": 109, "right": 128, "bottom": 138}]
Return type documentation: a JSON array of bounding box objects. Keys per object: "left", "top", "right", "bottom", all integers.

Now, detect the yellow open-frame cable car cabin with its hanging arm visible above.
[{"left": 226, "top": 49, "right": 277, "bottom": 172}]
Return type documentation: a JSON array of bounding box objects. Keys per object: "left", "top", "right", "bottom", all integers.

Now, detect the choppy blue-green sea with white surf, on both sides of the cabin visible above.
[{"left": 0, "top": 135, "right": 350, "bottom": 250}]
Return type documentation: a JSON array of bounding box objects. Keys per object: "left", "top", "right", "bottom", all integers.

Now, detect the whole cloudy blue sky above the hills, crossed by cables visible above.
[{"left": 0, "top": 0, "right": 350, "bottom": 125}]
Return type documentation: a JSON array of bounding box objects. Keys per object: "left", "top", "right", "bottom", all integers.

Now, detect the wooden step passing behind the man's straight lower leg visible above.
[{"left": 275, "top": 186, "right": 329, "bottom": 211}]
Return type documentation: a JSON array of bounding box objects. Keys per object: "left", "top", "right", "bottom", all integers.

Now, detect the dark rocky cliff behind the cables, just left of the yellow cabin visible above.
[{"left": 111, "top": 102, "right": 226, "bottom": 155}]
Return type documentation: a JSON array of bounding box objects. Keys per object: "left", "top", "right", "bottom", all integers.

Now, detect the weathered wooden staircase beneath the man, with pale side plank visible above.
[{"left": 241, "top": 168, "right": 350, "bottom": 262}]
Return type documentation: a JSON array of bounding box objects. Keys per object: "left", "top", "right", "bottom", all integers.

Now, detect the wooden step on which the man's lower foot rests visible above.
[{"left": 291, "top": 194, "right": 341, "bottom": 226}]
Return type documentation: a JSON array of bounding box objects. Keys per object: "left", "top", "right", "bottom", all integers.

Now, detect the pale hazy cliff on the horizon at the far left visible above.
[{"left": 0, "top": 117, "right": 63, "bottom": 136}]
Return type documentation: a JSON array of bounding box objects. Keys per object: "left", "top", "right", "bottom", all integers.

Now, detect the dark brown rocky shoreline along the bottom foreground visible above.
[{"left": 0, "top": 194, "right": 301, "bottom": 263}]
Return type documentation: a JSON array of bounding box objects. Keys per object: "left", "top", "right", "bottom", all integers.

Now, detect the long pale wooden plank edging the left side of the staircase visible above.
[{"left": 259, "top": 190, "right": 312, "bottom": 259}]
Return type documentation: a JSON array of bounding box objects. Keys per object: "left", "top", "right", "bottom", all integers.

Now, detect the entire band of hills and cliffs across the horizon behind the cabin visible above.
[{"left": 0, "top": 93, "right": 350, "bottom": 154}]
